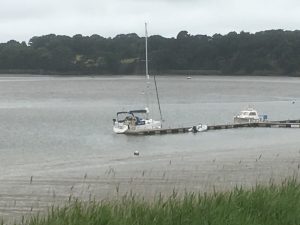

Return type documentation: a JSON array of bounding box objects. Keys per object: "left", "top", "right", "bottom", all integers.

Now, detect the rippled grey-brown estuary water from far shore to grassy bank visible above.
[{"left": 0, "top": 75, "right": 300, "bottom": 221}]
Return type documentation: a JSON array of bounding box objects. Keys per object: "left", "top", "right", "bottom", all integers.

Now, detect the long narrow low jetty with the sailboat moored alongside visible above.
[{"left": 124, "top": 120, "right": 300, "bottom": 135}]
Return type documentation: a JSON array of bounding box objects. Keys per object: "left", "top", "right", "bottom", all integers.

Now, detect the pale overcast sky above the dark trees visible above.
[{"left": 0, "top": 0, "right": 300, "bottom": 42}]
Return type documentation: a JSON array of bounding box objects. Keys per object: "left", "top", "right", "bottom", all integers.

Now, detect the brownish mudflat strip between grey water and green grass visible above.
[{"left": 0, "top": 145, "right": 300, "bottom": 221}]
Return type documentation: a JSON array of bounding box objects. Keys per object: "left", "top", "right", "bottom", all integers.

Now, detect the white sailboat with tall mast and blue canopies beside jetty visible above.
[{"left": 113, "top": 23, "right": 162, "bottom": 134}]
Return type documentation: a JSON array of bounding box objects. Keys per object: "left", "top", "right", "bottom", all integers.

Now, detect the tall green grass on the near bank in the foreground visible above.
[{"left": 8, "top": 180, "right": 300, "bottom": 225}]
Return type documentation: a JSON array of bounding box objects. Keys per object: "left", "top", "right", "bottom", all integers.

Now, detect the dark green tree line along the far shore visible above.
[{"left": 0, "top": 30, "right": 300, "bottom": 75}]
